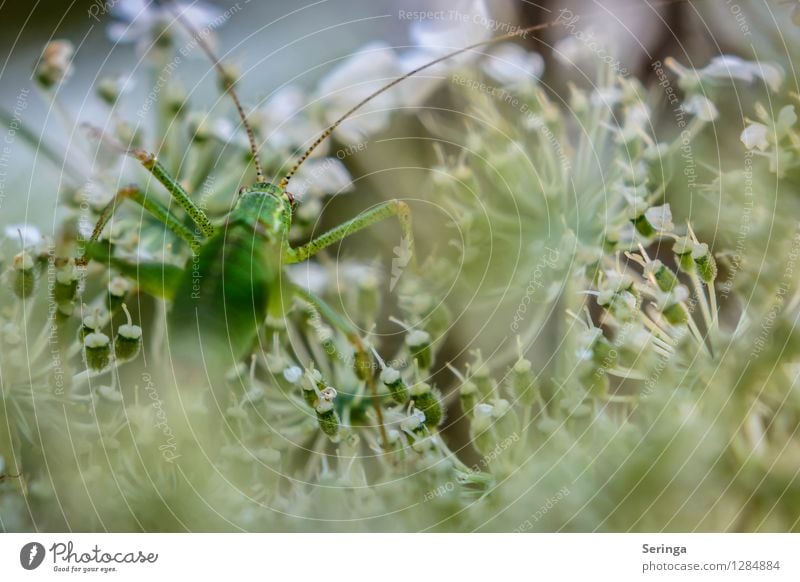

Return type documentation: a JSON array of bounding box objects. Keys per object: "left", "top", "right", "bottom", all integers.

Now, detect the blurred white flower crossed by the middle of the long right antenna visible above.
[{"left": 317, "top": 42, "right": 400, "bottom": 143}]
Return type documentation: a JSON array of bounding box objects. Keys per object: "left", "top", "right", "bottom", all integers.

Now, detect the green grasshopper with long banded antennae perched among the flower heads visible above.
[{"left": 77, "top": 5, "right": 554, "bottom": 442}]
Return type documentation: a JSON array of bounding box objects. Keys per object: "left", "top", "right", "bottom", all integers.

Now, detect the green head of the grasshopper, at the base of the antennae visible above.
[{"left": 236, "top": 182, "right": 293, "bottom": 239}]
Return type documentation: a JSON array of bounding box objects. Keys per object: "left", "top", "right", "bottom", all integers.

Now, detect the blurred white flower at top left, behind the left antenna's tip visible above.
[{"left": 107, "top": 0, "right": 223, "bottom": 54}]
